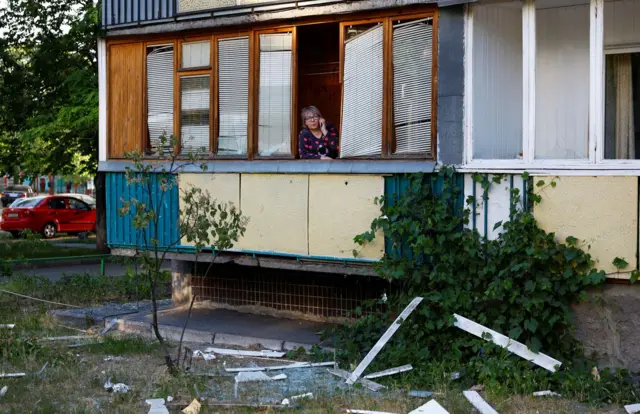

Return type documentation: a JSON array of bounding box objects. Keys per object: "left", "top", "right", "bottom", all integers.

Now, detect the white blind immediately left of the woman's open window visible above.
[{"left": 258, "top": 33, "right": 291, "bottom": 156}]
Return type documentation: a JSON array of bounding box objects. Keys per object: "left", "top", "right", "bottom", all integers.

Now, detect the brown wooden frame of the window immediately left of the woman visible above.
[{"left": 249, "top": 26, "right": 298, "bottom": 160}]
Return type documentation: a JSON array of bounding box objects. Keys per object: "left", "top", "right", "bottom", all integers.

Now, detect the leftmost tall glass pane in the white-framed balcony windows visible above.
[{"left": 472, "top": 1, "right": 522, "bottom": 160}]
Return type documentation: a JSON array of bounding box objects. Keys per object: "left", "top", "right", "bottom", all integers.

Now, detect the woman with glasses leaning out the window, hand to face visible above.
[{"left": 298, "top": 106, "right": 340, "bottom": 160}]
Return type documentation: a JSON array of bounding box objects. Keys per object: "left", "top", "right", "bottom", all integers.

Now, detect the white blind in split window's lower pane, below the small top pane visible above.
[{"left": 180, "top": 75, "right": 211, "bottom": 152}]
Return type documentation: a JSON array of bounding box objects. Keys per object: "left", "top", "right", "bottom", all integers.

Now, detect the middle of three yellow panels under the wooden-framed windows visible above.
[{"left": 235, "top": 174, "right": 309, "bottom": 255}]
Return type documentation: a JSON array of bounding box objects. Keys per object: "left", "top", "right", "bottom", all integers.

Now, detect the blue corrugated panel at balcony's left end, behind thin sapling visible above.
[{"left": 106, "top": 173, "right": 180, "bottom": 249}]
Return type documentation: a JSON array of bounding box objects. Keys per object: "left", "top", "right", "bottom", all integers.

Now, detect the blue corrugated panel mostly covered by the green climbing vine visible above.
[{"left": 384, "top": 174, "right": 464, "bottom": 257}]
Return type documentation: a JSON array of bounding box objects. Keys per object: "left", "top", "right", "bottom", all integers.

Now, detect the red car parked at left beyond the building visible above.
[{"left": 0, "top": 196, "right": 96, "bottom": 239}]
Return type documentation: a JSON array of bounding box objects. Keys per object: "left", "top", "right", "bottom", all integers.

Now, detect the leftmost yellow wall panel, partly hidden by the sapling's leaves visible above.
[{"left": 178, "top": 173, "right": 241, "bottom": 246}]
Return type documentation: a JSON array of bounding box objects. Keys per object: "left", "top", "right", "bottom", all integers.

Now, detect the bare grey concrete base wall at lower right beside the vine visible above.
[{"left": 574, "top": 285, "right": 640, "bottom": 372}]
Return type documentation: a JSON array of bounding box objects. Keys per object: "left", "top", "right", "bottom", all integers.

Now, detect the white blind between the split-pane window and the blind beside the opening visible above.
[{"left": 218, "top": 37, "right": 249, "bottom": 155}]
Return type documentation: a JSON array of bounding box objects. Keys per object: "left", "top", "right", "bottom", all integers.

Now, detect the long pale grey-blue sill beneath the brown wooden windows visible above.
[{"left": 98, "top": 160, "right": 436, "bottom": 174}]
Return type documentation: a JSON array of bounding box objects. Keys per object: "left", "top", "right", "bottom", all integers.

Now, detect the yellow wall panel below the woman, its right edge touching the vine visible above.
[{"left": 309, "top": 175, "right": 384, "bottom": 259}]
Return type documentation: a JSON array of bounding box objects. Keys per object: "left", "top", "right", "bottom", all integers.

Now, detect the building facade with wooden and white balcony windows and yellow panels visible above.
[{"left": 99, "top": 0, "right": 640, "bottom": 317}]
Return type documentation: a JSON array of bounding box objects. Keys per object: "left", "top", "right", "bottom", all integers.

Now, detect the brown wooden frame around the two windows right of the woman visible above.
[{"left": 339, "top": 10, "right": 438, "bottom": 160}]
